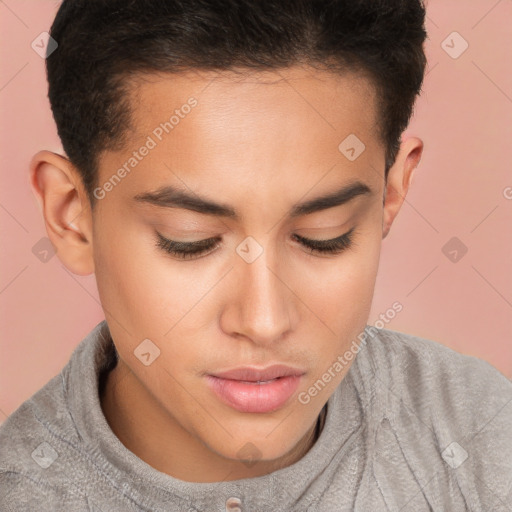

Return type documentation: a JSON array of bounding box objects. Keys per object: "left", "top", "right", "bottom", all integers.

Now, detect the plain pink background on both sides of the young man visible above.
[{"left": 0, "top": 0, "right": 512, "bottom": 423}]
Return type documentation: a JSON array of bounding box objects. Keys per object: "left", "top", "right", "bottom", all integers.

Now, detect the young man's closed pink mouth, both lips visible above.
[{"left": 206, "top": 365, "right": 306, "bottom": 413}]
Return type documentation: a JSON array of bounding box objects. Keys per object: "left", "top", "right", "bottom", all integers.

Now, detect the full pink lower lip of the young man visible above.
[{"left": 206, "top": 375, "right": 301, "bottom": 413}]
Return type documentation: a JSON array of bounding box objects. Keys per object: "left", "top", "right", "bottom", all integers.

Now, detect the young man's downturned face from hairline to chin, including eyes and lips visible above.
[{"left": 32, "top": 68, "right": 422, "bottom": 480}]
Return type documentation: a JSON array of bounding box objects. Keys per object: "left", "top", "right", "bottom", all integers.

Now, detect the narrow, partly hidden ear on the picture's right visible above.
[{"left": 382, "top": 137, "right": 423, "bottom": 238}]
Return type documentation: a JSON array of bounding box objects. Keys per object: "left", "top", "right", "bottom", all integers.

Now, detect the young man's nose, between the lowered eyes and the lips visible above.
[{"left": 221, "top": 241, "right": 296, "bottom": 345}]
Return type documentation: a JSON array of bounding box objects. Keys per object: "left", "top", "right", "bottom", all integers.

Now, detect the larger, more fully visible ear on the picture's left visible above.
[{"left": 30, "top": 151, "right": 94, "bottom": 275}]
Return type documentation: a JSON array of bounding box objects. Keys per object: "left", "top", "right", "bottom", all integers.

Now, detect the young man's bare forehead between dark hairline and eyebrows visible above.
[{"left": 96, "top": 67, "right": 384, "bottom": 212}]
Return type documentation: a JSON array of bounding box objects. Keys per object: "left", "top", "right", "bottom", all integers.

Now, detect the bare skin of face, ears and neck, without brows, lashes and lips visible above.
[{"left": 30, "top": 67, "right": 423, "bottom": 482}]
